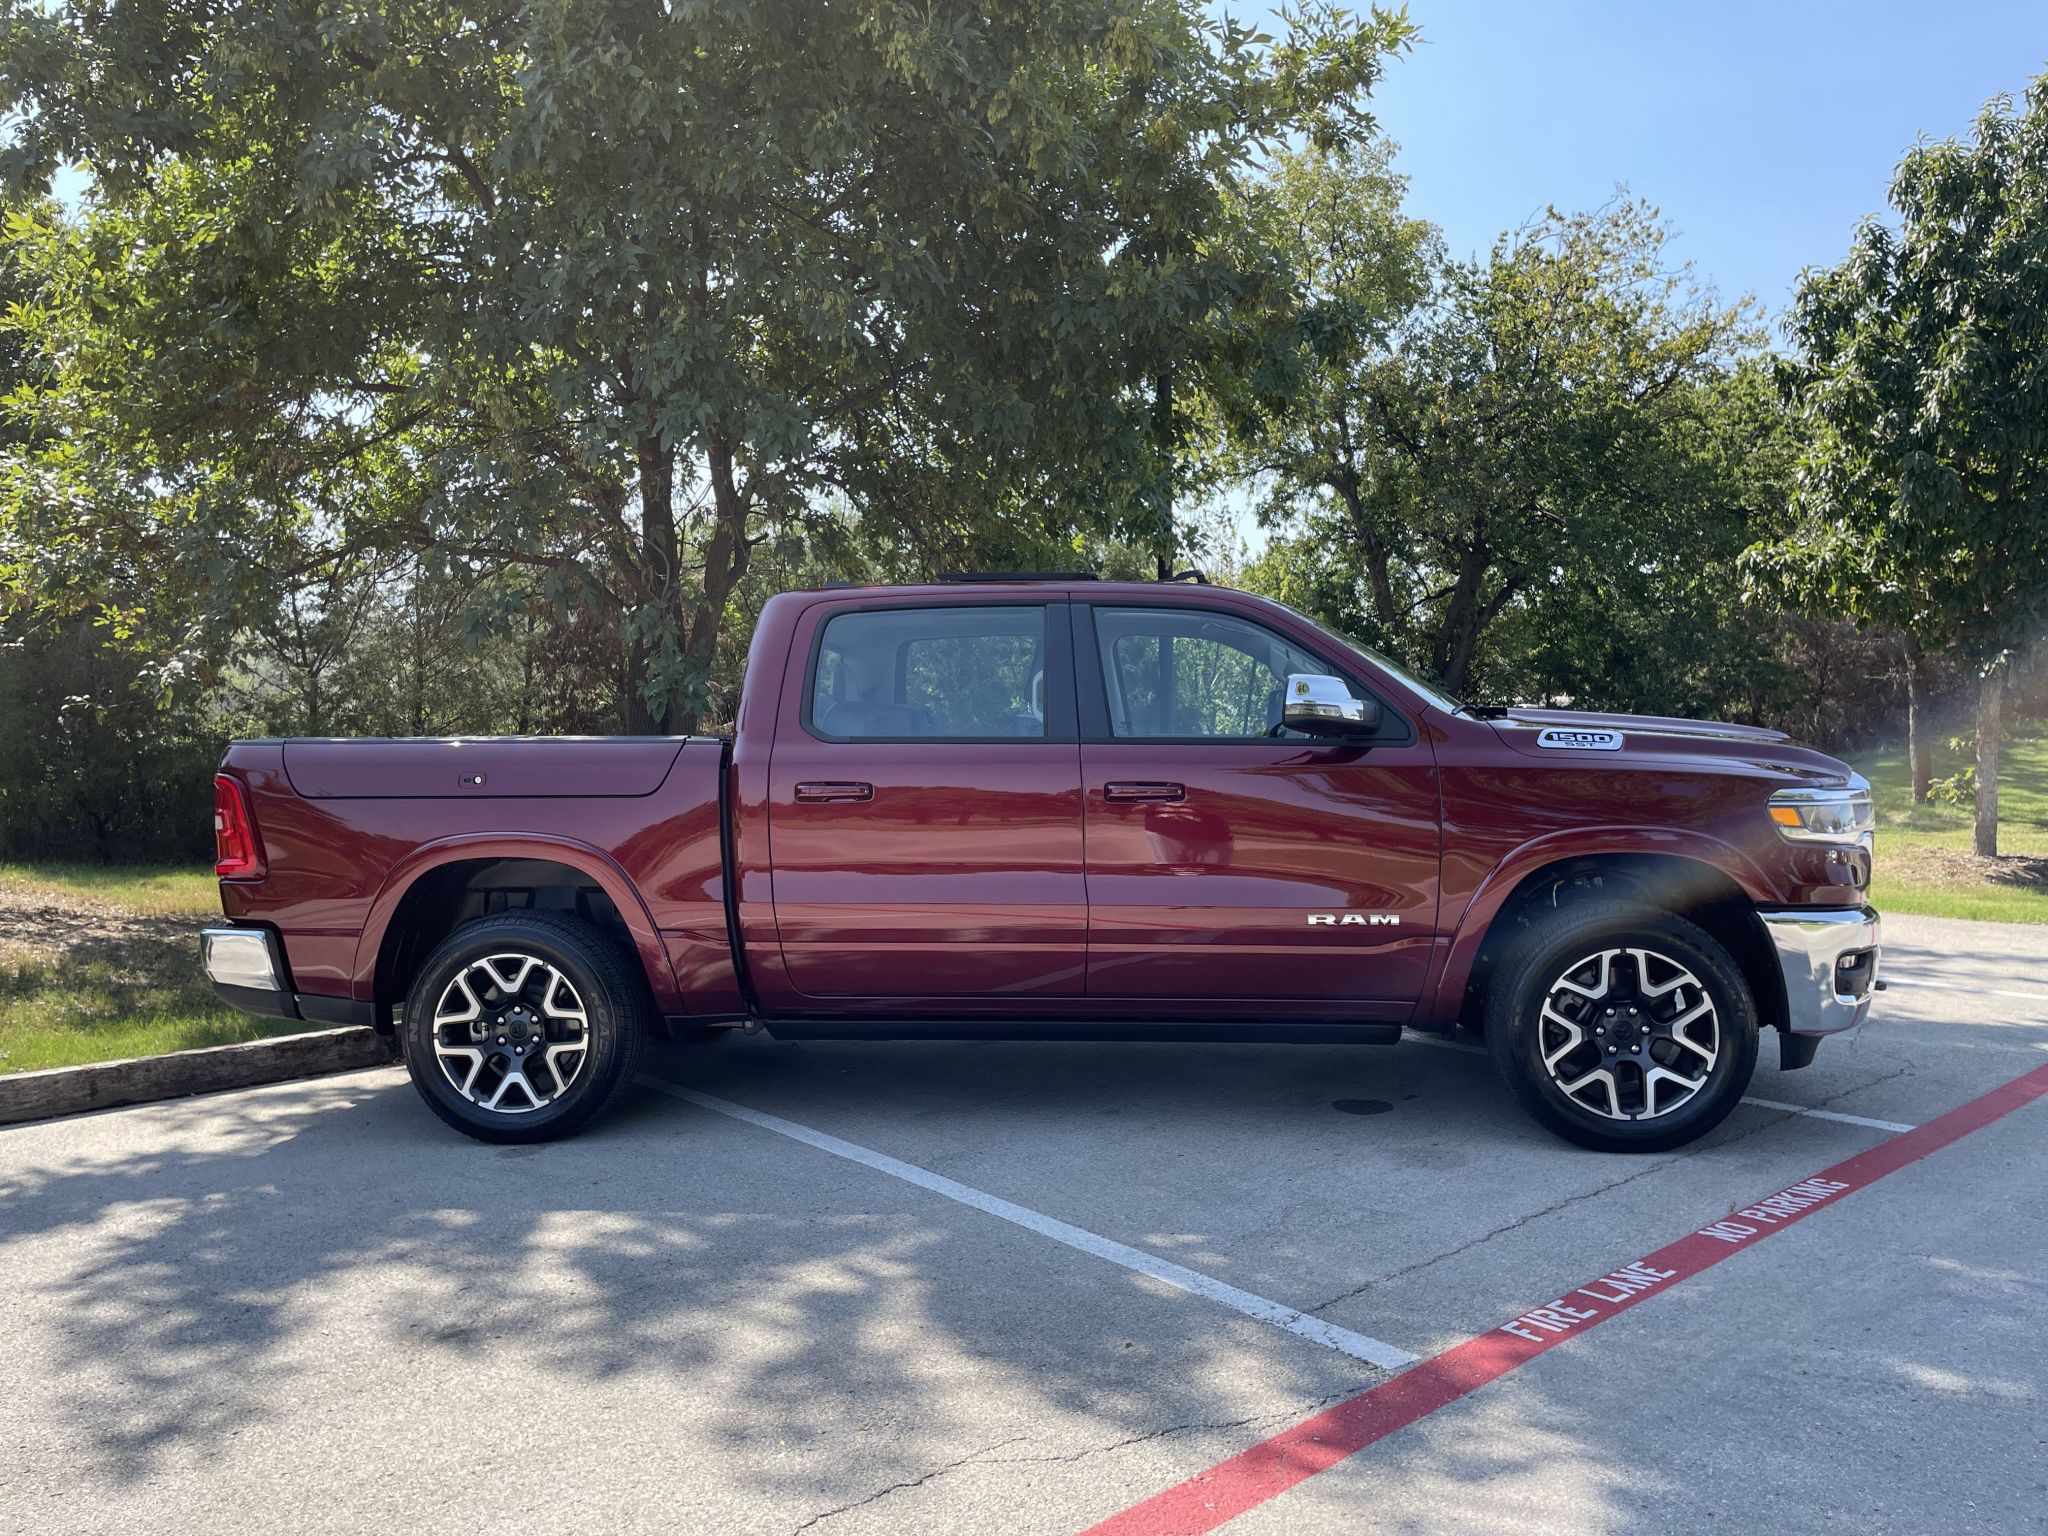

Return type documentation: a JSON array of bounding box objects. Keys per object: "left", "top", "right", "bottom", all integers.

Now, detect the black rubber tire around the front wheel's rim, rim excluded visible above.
[{"left": 1487, "top": 911, "right": 1757, "bottom": 1151}]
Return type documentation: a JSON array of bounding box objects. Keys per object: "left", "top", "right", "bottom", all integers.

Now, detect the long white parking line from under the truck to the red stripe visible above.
[{"left": 639, "top": 1075, "right": 1417, "bottom": 1370}]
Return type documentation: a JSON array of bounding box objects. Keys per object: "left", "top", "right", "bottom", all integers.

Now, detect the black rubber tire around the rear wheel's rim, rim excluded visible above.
[{"left": 401, "top": 915, "right": 639, "bottom": 1141}]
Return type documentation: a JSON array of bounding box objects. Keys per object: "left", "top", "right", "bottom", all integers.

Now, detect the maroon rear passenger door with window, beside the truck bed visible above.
[{"left": 768, "top": 598, "right": 1087, "bottom": 999}]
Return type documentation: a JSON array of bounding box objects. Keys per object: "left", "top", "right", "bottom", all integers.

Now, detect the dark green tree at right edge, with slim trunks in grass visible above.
[{"left": 1751, "top": 76, "right": 2048, "bottom": 854}]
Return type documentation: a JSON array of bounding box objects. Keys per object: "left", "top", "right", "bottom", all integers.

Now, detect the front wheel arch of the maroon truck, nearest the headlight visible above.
[{"left": 1434, "top": 840, "right": 1786, "bottom": 1028}]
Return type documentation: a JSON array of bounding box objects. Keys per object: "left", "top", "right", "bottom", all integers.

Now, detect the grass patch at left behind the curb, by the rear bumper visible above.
[{"left": 0, "top": 864, "right": 311, "bottom": 1073}]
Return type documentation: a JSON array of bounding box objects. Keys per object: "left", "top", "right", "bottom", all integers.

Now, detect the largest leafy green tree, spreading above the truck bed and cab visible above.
[{"left": 0, "top": 0, "right": 1409, "bottom": 729}]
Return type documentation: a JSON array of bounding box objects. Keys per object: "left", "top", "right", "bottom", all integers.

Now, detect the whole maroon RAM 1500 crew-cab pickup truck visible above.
[{"left": 203, "top": 575, "right": 1878, "bottom": 1151}]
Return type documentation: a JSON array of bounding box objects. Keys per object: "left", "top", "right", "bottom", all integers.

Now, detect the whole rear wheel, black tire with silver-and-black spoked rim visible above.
[{"left": 399, "top": 911, "right": 653, "bottom": 1143}]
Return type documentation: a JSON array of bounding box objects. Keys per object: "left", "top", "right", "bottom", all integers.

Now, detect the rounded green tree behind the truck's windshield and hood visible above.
[{"left": 1231, "top": 182, "right": 1776, "bottom": 702}]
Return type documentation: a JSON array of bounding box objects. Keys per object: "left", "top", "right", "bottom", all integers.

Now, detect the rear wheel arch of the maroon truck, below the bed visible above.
[{"left": 352, "top": 834, "right": 680, "bottom": 1030}]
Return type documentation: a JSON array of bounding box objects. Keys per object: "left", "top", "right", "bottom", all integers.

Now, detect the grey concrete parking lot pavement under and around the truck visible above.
[{"left": 0, "top": 920, "right": 2048, "bottom": 1536}]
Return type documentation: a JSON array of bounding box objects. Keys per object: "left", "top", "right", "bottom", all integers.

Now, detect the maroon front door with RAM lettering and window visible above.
[{"left": 1075, "top": 602, "right": 1440, "bottom": 1016}]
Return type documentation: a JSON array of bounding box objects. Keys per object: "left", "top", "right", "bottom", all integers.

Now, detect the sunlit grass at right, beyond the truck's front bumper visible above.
[{"left": 1853, "top": 737, "right": 2048, "bottom": 924}]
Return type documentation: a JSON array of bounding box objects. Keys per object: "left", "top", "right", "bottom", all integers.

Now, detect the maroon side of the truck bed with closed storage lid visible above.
[{"left": 221, "top": 737, "right": 739, "bottom": 1022}]
